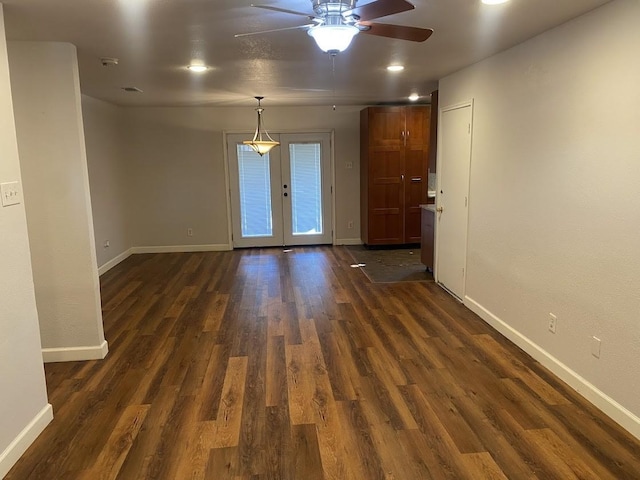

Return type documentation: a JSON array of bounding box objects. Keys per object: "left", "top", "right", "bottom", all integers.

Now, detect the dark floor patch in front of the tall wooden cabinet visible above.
[{"left": 347, "top": 245, "right": 433, "bottom": 283}]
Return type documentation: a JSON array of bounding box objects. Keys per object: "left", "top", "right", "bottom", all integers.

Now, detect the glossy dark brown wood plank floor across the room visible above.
[{"left": 6, "top": 247, "right": 640, "bottom": 480}]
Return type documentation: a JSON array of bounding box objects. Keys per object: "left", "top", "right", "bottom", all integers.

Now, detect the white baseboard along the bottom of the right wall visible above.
[{"left": 464, "top": 296, "right": 640, "bottom": 439}]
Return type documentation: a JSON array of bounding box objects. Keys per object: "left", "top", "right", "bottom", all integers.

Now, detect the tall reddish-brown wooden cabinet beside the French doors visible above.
[{"left": 360, "top": 105, "right": 431, "bottom": 245}]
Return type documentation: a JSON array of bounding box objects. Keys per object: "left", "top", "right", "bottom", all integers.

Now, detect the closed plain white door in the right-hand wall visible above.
[{"left": 435, "top": 103, "right": 473, "bottom": 299}]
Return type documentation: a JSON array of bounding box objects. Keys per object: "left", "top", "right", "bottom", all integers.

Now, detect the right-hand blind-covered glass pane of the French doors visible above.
[{"left": 289, "top": 143, "right": 322, "bottom": 235}]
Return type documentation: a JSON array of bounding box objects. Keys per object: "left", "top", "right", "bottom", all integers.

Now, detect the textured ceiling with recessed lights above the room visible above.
[{"left": 3, "top": 0, "right": 608, "bottom": 106}]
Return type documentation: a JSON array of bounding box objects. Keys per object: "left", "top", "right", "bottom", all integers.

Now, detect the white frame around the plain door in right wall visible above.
[{"left": 433, "top": 99, "right": 475, "bottom": 303}]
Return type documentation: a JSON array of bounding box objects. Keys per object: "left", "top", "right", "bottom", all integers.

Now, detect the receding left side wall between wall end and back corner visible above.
[{"left": 82, "top": 95, "right": 133, "bottom": 269}]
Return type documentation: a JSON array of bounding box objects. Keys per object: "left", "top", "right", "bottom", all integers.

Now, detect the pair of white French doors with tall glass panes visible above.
[{"left": 227, "top": 133, "right": 332, "bottom": 247}]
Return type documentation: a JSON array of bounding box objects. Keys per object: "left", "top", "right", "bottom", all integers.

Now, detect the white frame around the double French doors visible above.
[{"left": 222, "top": 128, "right": 337, "bottom": 250}]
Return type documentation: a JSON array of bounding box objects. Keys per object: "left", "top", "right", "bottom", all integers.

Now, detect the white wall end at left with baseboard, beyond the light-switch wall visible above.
[{"left": 8, "top": 42, "right": 107, "bottom": 361}]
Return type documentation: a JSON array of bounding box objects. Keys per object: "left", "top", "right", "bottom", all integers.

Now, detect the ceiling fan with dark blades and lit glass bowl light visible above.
[{"left": 235, "top": 0, "right": 433, "bottom": 55}]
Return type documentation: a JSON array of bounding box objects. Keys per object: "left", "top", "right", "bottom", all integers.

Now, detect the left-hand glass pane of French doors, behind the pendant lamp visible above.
[{"left": 237, "top": 145, "right": 273, "bottom": 237}]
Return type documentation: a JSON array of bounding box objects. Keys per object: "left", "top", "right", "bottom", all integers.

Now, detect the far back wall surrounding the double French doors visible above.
[{"left": 123, "top": 102, "right": 361, "bottom": 248}]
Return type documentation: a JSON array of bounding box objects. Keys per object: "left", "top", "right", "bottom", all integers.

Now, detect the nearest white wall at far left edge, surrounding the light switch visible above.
[{"left": 0, "top": 5, "right": 52, "bottom": 478}]
